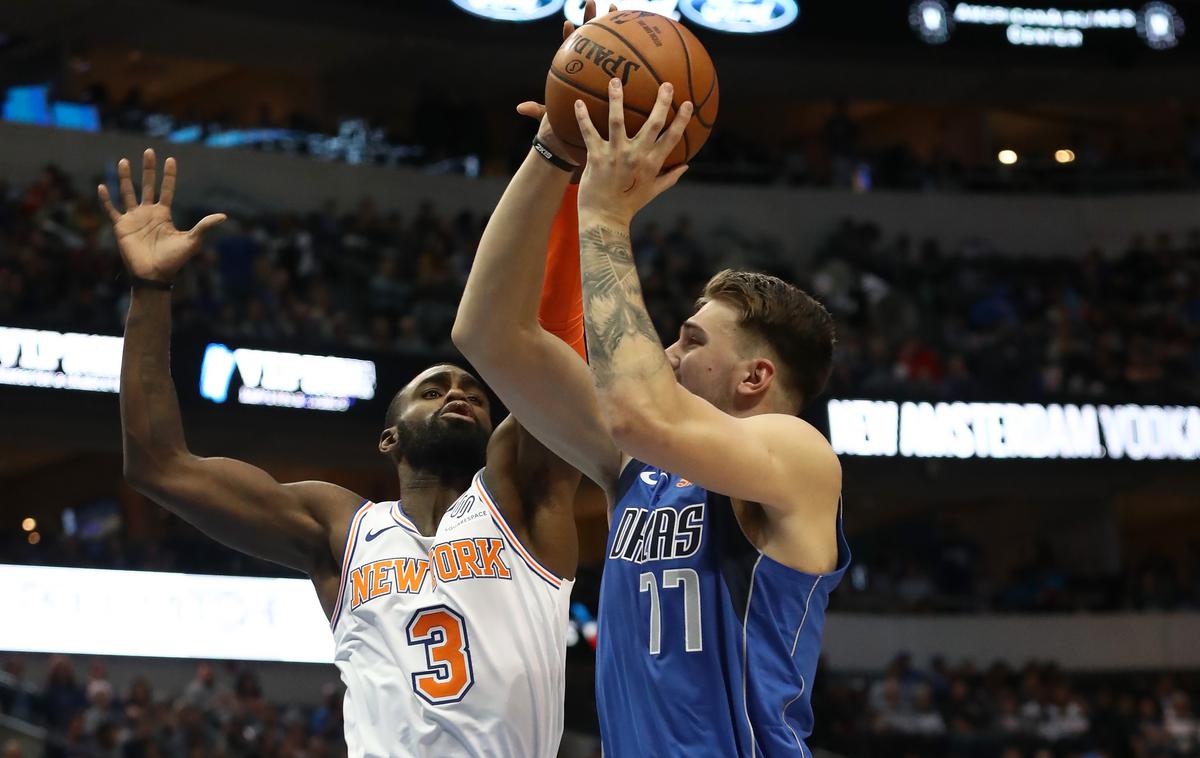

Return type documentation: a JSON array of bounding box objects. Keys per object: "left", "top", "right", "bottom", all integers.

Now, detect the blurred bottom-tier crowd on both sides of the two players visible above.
[{"left": 9, "top": 652, "right": 1200, "bottom": 758}]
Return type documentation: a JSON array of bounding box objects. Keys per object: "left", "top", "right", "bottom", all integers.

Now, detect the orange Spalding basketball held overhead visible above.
[{"left": 546, "top": 11, "right": 720, "bottom": 168}]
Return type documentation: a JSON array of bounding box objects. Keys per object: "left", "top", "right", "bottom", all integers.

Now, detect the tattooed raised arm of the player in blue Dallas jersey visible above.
[{"left": 575, "top": 79, "right": 841, "bottom": 512}]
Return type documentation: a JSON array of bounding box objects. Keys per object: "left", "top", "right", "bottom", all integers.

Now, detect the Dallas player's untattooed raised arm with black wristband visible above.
[{"left": 452, "top": 2, "right": 620, "bottom": 491}]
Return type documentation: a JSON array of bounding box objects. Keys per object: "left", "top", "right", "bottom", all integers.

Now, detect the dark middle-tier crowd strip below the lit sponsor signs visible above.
[{"left": 0, "top": 499, "right": 1200, "bottom": 614}]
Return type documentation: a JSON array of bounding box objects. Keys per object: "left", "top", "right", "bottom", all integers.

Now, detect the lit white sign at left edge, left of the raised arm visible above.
[{"left": 0, "top": 326, "right": 124, "bottom": 392}]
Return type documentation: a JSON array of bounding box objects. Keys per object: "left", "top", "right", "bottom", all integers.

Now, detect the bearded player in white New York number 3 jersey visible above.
[{"left": 100, "top": 150, "right": 582, "bottom": 758}]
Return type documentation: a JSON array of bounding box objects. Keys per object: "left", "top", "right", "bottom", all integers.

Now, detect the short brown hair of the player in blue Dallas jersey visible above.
[{"left": 696, "top": 269, "right": 835, "bottom": 410}]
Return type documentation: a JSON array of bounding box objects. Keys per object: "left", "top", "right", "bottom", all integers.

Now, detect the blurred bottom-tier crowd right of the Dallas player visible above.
[{"left": 810, "top": 654, "right": 1200, "bottom": 758}]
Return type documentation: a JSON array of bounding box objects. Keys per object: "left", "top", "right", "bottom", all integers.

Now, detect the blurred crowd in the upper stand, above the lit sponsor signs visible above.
[{"left": 0, "top": 167, "right": 1200, "bottom": 402}]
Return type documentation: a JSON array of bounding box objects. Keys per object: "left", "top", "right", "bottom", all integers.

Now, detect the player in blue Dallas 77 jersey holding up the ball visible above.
[{"left": 454, "top": 8, "right": 850, "bottom": 758}]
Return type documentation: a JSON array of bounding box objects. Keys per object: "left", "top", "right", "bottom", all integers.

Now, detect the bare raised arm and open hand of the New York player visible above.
[{"left": 100, "top": 150, "right": 360, "bottom": 576}]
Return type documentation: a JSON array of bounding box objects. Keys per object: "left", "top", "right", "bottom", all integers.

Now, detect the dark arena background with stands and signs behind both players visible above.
[{"left": 0, "top": 0, "right": 1200, "bottom": 758}]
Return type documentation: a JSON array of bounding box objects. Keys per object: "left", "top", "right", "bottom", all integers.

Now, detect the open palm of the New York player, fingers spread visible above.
[{"left": 98, "top": 150, "right": 226, "bottom": 282}]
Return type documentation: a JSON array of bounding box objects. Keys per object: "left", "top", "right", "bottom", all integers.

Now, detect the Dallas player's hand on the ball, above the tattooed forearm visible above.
[{"left": 575, "top": 79, "right": 692, "bottom": 225}]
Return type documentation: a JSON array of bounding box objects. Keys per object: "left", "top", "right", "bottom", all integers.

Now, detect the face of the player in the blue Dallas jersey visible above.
[{"left": 667, "top": 300, "right": 745, "bottom": 411}]
